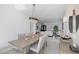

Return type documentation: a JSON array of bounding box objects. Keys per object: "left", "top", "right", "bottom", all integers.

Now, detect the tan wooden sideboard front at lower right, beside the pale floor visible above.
[{"left": 60, "top": 40, "right": 76, "bottom": 54}]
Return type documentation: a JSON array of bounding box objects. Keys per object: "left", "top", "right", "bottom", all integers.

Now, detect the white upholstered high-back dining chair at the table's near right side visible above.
[{"left": 30, "top": 35, "right": 47, "bottom": 54}]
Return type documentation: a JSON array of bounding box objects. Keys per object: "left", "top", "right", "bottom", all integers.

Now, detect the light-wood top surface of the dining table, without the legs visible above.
[{"left": 9, "top": 37, "right": 39, "bottom": 49}]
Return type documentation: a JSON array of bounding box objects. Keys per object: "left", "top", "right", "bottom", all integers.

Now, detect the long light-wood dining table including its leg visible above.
[{"left": 8, "top": 35, "right": 41, "bottom": 54}]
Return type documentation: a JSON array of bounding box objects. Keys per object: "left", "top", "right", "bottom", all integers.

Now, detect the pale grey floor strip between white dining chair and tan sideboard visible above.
[{"left": 45, "top": 37, "right": 59, "bottom": 54}]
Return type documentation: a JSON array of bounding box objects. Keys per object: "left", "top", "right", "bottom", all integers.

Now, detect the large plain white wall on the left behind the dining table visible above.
[{"left": 0, "top": 5, "right": 30, "bottom": 49}]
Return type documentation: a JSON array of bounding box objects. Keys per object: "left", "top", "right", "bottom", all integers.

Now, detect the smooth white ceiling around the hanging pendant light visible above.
[{"left": 12, "top": 4, "right": 68, "bottom": 21}]
